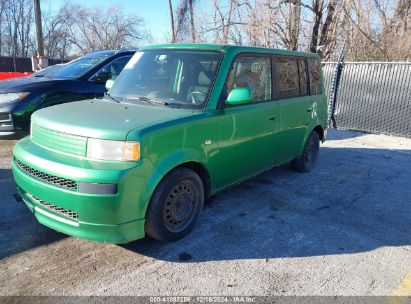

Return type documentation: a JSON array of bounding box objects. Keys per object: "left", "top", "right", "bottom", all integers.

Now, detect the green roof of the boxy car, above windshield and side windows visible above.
[{"left": 140, "top": 43, "right": 319, "bottom": 57}]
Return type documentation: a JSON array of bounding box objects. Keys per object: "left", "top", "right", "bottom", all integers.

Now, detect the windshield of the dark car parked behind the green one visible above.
[{"left": 53, "top": 56, "right": 107, "bottom": 78}]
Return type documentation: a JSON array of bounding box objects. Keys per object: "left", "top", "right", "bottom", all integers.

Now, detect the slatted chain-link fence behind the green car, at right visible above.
[{"left": 323, "top": 62, "right": 411, "bottom": 138}]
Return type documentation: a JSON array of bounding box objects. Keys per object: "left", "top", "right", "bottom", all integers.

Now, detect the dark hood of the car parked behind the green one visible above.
[{"left": 0, "top": 77, "right": 67, "bottom": 94}]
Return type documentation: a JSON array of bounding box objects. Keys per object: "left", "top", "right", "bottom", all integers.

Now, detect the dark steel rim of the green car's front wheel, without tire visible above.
[{"left": 163, "top": 180, "right": 198, "bottom": 233}]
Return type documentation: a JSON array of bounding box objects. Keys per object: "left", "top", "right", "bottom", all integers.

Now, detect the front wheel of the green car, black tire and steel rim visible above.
[{"left": 145, "top": 168, "right": 204, "bottom": 242}]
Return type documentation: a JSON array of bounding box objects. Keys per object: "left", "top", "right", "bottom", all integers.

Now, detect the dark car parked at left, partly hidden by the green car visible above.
[{"left": 0, "top": 50, "right": 135, "bottom": 137}]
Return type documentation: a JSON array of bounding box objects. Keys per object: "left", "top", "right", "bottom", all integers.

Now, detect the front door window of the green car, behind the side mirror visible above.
[{"left": 226, "top": 56, "right": 271, "bottom": 102}]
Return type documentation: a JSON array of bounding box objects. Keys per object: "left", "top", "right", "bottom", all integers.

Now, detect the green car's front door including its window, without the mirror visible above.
[{"left": 216, "top": 54, "right": 279, "bottom": 186}]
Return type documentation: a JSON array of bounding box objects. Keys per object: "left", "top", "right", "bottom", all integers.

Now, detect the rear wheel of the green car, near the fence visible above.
[{"left": 291, "top": 131, "right": 320, "bottom": 172}]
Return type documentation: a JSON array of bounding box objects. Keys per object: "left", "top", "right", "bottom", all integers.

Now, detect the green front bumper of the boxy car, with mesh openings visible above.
[{"left": 12, "top": 138, "right": 158, "bottom": 243}]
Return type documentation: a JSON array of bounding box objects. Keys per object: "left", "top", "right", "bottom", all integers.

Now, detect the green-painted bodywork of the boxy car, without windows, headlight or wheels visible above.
[{"left": 12, "top": 44, "right": 327, "bottom": 243}]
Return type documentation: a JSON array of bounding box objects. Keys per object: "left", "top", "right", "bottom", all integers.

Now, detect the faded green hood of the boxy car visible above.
[{"left": 32, "top": 99, "right": 193, "bottom": 140}]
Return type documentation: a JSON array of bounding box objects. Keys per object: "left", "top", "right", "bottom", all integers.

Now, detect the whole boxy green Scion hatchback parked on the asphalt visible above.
[{"left": 12, "top": 44, "right": 327, "bottom": 243}]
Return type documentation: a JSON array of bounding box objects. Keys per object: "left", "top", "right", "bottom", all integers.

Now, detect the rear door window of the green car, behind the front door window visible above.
[{"left": 276, "top": 57, "right": 300, "bottom": 99}]
